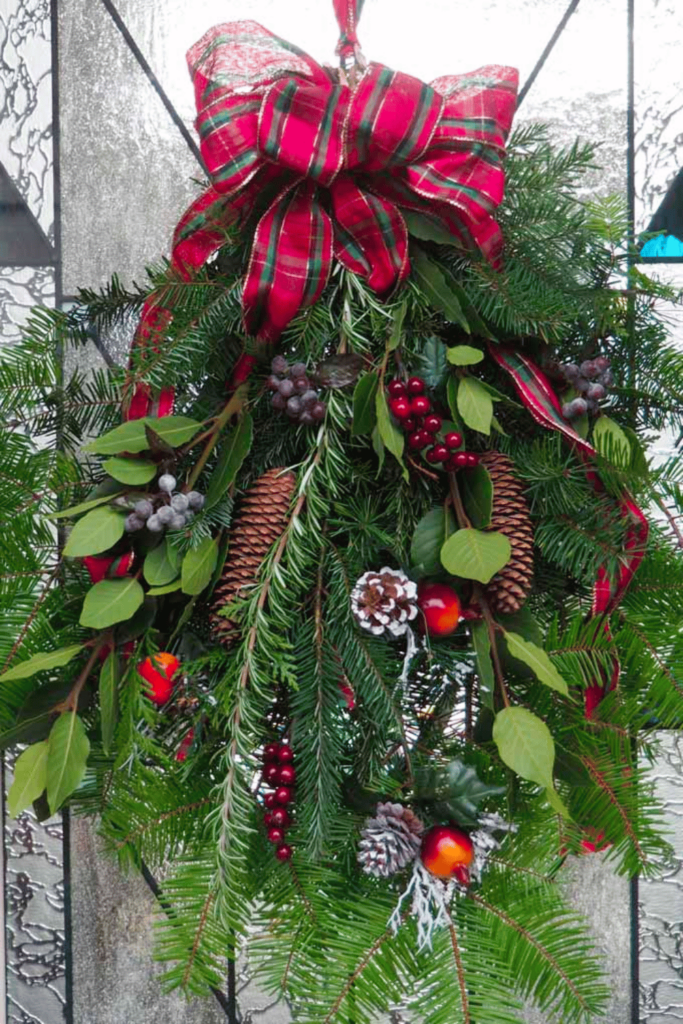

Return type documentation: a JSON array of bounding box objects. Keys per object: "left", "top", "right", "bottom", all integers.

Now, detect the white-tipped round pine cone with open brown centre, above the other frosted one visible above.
[{"left": 351, "top": 565, "right": 418, "bottom": 637}]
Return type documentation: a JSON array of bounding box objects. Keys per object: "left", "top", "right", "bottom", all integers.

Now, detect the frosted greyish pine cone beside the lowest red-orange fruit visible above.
[{"left": 358, "top": 803, "right": 424, "bottom": 879}]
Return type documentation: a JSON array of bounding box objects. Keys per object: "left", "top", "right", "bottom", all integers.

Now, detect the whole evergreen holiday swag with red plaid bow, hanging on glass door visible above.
[{"left": 0, "top": 0, "right": 683, "bottom": 1024}]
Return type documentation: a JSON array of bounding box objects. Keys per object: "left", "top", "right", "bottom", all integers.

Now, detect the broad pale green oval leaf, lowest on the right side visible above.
[{"left": 494, "top": 708, "right": 555, "bottom": 790}]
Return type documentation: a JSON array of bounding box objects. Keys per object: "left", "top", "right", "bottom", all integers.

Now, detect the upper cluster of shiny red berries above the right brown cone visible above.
[{"left": 387, "top": 377, "right": 479, "bottom": 473}]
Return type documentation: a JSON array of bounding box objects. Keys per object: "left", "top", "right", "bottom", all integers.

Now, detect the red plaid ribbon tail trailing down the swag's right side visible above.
[{"left": 488, "top": 344, "right": 649, "bottom": 718}]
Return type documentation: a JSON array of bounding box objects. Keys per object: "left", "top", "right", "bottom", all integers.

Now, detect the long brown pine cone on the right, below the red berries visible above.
[{"left": 481, "top": 452, "right": 533, "bottom": 614}]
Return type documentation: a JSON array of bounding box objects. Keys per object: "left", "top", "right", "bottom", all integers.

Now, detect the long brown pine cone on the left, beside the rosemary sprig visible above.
[{"left": 211, "top": 468, "right": 296, "bottom": 646}]
